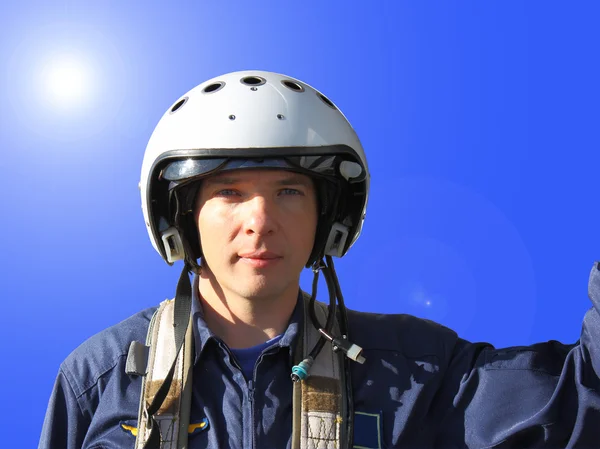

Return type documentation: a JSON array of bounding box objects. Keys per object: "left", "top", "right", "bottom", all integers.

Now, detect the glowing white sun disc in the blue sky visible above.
[{"left": 41, "top": 55, "right": 91, "bottom": 109}]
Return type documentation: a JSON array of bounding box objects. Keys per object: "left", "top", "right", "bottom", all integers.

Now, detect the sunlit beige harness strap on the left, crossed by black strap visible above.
[{"left": 135, "top": 300, "right": 193, "bottom": 449}]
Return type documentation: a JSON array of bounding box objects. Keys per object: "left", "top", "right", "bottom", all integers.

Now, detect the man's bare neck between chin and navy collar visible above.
[{"left": 198, "top": 269, "right": 300, "bottom": 349}]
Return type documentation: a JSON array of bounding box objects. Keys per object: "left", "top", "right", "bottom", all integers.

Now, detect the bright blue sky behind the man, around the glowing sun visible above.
[{"left": 0, "top": 0, "right": 600, "bottom": 447}]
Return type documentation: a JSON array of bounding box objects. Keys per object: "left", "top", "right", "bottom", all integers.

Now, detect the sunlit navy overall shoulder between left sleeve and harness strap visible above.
[{"left": 60, "top": 307, "right": 157, "bottom": 395}]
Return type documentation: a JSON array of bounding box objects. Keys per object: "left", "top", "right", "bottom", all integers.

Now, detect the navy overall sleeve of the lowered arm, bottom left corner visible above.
[{"left": 38, "top": 369, "right": 90, "bottom": 449}]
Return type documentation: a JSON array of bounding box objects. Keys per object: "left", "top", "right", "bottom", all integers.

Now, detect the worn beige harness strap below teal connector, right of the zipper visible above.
[{"left": 292, "top": 292, "right": 345, "bottom": 449}]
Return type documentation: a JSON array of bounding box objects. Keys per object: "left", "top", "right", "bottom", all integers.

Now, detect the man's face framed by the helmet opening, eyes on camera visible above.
[{"left": 196, "top": 169, "right": 317, "bottom": 298}]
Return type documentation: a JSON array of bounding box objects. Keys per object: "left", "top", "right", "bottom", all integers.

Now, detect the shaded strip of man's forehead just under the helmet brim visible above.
[{"left": 202, "top": 168, "right": 313, "bottom": 187}]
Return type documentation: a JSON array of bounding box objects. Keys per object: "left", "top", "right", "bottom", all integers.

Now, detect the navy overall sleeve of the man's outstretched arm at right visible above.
[{"left": 436, "top": 262, "right": 600, "bottom": 449}]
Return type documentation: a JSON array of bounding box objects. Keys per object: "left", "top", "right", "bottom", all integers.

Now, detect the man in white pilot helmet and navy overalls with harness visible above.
[{"left": 40, "top": 71, "right": 600, "bottom": 449}]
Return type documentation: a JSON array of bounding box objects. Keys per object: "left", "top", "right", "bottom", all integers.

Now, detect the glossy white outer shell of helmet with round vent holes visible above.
[{"left": 139, "top": 70, "right": 370, "bottom": 263}]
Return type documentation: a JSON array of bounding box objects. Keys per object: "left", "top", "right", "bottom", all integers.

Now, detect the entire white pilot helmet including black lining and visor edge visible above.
[{"left": 140, "top": 70, "right": 370, "bottom": 266}]
